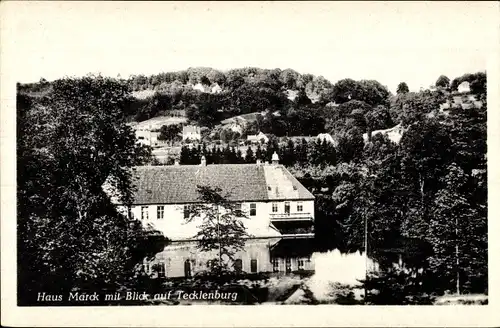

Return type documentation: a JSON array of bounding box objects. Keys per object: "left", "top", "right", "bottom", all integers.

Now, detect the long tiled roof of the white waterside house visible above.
[{"left": 127, "top": 164, "right": 314, "bottom": 204}]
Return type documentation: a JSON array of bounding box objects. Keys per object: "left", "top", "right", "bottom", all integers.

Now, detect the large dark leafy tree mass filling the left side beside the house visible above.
[{"left": 17, "top": 76, "right": 162, "bottom": 304}]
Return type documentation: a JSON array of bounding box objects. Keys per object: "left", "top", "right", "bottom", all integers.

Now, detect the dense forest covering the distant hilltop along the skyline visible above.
[{"left": 18, "top": 67, "right": 486, "bottom": 140}]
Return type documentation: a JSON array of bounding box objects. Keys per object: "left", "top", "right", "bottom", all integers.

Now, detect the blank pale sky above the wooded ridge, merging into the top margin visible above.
[{"left": 1, "top": 1, "right": 500, "bottom": 92}]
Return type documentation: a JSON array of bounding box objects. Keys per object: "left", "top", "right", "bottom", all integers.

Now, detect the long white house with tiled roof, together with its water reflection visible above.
[{"left": 118, "top": 154, "right": 314, "bottom": 277}]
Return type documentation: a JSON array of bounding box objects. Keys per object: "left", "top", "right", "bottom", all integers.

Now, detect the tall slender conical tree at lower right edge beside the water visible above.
[{"left": 428, "top": 163, "right": 488, "bottom": 294}]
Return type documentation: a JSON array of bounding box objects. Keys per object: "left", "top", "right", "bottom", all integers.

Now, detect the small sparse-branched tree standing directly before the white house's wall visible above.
[{"left": 186, "top": 186, "right": 250, "bottom": 276}]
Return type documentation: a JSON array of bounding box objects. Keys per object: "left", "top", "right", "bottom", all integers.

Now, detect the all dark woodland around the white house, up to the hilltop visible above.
[{"left": 17, "top": 68, "right": 488, "bottom": 304}]
